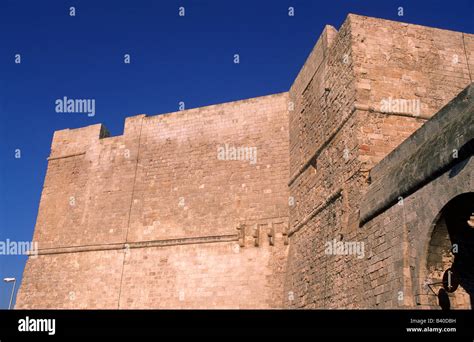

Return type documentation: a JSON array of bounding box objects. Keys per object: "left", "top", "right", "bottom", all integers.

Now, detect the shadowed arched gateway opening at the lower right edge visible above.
[{"left": 420, "top": 192, "right": 474, "bottom": 309}]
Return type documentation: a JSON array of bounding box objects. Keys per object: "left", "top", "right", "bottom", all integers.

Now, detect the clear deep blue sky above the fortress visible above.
[{"left": 0, "top": 0, "right": 474, "bottom": 308}]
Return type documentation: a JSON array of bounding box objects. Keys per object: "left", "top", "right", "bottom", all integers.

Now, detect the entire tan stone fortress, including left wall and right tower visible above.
[{"left": 17, "top": 14, "right": 474, "bottom": 308}]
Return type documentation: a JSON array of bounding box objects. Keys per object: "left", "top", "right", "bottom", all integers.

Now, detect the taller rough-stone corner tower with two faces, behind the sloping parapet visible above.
[{"left": 284, "top": 15, "right": 473, "bottom": 308}]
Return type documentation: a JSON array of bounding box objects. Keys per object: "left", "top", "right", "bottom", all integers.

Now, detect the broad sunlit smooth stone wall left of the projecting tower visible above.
[{"left": 17, "top": 93, "right": 289, "bottom": 308}]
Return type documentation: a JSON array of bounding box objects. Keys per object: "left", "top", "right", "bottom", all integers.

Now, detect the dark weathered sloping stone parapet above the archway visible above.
[{"left": 360, "top": 85, "right": 474, "bottom": 223}]
